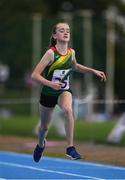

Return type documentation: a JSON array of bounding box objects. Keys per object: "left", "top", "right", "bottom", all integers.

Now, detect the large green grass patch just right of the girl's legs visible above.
[{"left": 75, "top": 121, "right": 115, "bottom": 143}]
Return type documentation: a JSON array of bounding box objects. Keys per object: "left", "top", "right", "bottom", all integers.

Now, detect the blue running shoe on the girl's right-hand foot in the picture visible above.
[{"left": 66, "top": 146, "right": 81, "bottom": 160}]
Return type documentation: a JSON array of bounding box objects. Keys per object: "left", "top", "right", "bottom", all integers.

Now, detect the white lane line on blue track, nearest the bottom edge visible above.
[{"left": 0, "top": 161, "right": 105, "bottom": 180}]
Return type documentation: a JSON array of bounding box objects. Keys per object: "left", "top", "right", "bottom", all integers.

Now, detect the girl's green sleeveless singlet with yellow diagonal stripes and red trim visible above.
[{"left": 42, "top": 47, "right": 72, "bottom": 96}]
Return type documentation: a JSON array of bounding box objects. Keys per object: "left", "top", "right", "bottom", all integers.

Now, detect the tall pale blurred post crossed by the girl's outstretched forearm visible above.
[{"left": 78, "top": 10, "right": 95, "bottom": 116}]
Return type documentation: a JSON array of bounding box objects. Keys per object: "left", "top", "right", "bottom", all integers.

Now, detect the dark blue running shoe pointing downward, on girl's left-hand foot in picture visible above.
[{"left": 33, "top": 141, "right": 45, "bottom": 162}]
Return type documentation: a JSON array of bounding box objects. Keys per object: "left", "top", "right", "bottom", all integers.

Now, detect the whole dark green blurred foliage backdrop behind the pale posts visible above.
[{"left": 0, "top": 0, "right": 125, "bottom": 115}]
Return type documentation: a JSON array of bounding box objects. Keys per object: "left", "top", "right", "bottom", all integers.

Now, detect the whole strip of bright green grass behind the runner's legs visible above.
[{"left": 0, "top": 116, "right": 125, "bottom": 145}]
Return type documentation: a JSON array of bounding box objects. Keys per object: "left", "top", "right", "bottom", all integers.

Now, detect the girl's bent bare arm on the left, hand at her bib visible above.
[{"left": 31, "top": 49, "right": 61, "bottom": 90}]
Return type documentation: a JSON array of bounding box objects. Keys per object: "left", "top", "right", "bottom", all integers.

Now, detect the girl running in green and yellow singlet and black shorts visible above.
[{"left": 31, "top": 22, "right": 106, "bottom": 162}]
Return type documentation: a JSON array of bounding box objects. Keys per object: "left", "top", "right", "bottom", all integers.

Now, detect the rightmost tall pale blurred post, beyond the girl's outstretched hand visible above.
[{"left": 105, "top": 9, "right": 115, "bottom": 114}]
